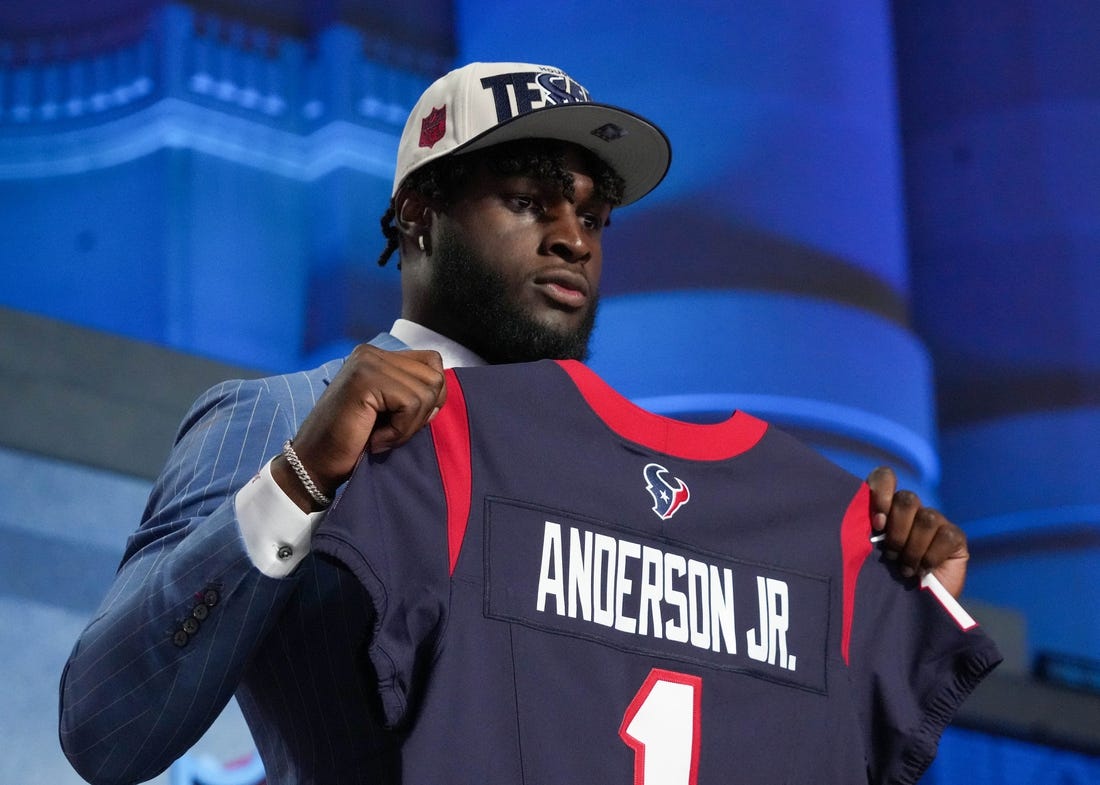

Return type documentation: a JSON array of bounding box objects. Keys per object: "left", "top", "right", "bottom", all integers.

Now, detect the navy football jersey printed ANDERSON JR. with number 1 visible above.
[{"left": 315, "top": 361, "right": 1000, "bottom": 785}]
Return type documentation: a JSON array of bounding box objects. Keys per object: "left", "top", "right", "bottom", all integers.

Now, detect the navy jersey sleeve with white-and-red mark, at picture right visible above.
[{"left": 845, "top": 486, "right": 1001, "bottom": 785}]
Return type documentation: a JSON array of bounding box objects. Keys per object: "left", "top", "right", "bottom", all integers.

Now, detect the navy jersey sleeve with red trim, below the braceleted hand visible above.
[{"left": 314, "top": 374, "right": 470, "bottom": 728}]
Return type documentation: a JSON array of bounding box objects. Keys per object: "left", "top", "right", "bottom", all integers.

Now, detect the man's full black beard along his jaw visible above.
[{"left": 429, "top": 224, "right": 600, "bottom": 363}]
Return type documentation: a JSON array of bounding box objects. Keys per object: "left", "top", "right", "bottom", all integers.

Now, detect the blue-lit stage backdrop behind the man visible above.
[{"left": 0, "top": 0, "right": 1100, "bottom": 783}]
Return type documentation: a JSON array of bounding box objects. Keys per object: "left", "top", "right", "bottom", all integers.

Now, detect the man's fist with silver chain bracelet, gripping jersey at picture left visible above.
[{"left": 272, "top": 343, "right": 447, "bottom": 512}]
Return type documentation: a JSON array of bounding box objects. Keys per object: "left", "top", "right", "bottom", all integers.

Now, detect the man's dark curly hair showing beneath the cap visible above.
[{"left": 378, "top": 139, "right": 625, "bottom": 267}]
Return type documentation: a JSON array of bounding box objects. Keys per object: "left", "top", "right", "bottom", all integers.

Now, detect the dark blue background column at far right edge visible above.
[{"left": 894, "top": 0, "right": 1100, "bottom": 660}]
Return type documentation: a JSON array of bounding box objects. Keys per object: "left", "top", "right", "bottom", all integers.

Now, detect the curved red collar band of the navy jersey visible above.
[{"left": 557, "top": 360, "right": 768, "bottom": 461}]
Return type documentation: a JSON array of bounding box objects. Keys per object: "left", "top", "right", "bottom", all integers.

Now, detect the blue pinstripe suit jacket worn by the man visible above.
[{"left": 59, "top": 334, "right": 406, "bottom": 785}]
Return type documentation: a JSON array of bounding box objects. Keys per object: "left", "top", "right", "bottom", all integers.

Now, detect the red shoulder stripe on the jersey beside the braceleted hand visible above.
[{"left": 429, "top": 371, "right": 473, "bottom": 575}]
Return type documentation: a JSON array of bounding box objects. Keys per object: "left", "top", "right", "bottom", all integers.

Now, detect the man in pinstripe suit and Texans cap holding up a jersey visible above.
[{"left": 61, "top": 63, "right": 967, "bottom": 783}]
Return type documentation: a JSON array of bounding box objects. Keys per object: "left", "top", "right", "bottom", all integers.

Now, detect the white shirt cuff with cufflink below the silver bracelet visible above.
[{"left": 233, "top": 462, "right": 325, "bottom": 578}]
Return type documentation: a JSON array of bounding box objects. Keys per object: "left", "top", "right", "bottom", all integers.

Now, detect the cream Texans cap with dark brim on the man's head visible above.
[{"left": 393, "top": 63, "right": 672, "bottom": 204}]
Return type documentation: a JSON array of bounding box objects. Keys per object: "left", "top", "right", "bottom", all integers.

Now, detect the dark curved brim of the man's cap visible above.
[{"left": 450, "top": 103, "right": 672, "bottom": 204}]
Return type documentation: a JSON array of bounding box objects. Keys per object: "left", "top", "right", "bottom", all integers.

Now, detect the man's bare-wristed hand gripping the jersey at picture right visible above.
[{"left": 867, "top": 466, "right": 970, "bottom": 597}]
